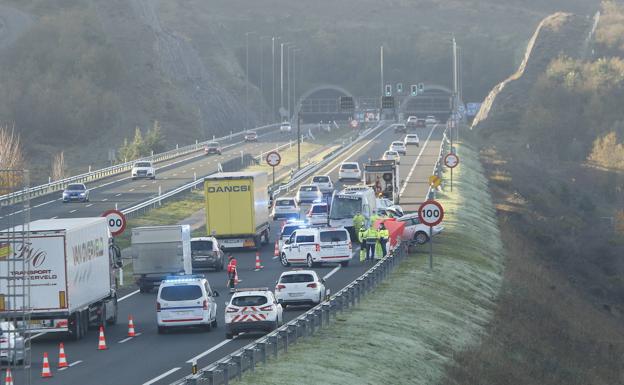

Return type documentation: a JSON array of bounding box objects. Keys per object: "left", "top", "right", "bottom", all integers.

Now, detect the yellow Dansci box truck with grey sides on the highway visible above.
[{"left": 204, "top": 172, "right": 270, "bottom": 249}]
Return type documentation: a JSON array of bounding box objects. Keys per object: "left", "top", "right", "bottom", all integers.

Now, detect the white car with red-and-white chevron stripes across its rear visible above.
[{"left": 225, "top": 288, "right": 283, "bottom": 339}]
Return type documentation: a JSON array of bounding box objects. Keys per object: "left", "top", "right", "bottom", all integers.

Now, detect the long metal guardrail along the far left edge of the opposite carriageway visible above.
[{"left": 0, "top": 123, "right": 279, "bottom": 205}]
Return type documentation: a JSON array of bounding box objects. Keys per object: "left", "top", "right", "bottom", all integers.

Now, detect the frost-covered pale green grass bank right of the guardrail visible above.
[{"left": 236, "top": 142, "right": 503, "bottom": 385}]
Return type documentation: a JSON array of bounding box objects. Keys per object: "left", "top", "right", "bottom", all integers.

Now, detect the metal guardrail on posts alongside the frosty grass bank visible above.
[{"left": 171, "top": 240, "right": 407, "bottom": 385}]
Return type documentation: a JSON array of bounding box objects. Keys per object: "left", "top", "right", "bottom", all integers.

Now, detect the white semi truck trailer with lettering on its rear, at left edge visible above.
[{"left": 0, "top": 217, "right": 121, "bottom": 340}]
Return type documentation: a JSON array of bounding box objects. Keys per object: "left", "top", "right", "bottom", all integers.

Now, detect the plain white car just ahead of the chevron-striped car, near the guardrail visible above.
[{"left": 275, "top": 269, "right": 327, "bottom": 308}]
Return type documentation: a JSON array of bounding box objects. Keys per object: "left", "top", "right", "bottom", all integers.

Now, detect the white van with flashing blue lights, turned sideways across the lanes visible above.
[{"left": 280, "top": 227, "right": 353, "bottom": 268}]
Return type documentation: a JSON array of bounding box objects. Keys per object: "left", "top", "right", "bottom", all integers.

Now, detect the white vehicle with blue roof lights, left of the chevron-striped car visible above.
[{"left": 156, "top": 275, "right": 219, "bottom": 333}]
